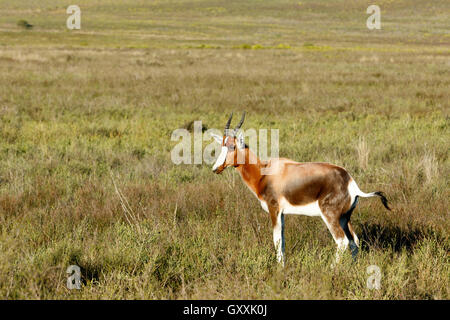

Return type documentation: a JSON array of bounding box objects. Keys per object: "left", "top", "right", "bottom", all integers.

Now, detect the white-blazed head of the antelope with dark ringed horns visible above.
[{"left": 212, "top": 112, "right": 245, "bottom": 174}]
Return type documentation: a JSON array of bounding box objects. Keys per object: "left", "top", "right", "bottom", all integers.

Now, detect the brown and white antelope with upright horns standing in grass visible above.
[{"left": 212, "top": 112, "right": 391, "bottom": 266}]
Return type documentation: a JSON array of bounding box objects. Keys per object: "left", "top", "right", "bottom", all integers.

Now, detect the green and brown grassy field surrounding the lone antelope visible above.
[{"left": 0, "top": 0, "right": 450, "bottom": 299}]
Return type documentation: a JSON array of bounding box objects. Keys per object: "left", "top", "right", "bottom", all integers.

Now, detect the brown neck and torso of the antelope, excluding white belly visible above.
[{"left": 235, "top": 148, "right": 356, "bottom": 244}]
